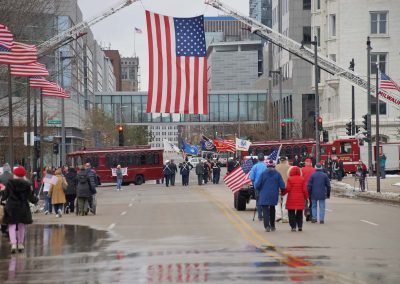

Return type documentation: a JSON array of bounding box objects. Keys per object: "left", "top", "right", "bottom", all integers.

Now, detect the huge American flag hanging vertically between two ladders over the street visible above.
[{"left": 146, "top": 11, "right": 208, "bottom": 114}]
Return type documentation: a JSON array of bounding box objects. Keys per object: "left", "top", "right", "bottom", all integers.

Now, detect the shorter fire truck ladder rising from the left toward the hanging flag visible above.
[{"left": 38, "top": 0, "right": 139, "bottom": 57}]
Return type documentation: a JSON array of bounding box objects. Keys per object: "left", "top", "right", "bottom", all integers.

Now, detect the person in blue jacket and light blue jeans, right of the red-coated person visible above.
[{"left": 307, "top": 164, "right": 331, "bottom": 224}]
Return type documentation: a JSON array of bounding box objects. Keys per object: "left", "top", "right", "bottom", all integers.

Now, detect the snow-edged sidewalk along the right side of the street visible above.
[{"left": 331, "top": 175, "right": 400, "bottom": 205}]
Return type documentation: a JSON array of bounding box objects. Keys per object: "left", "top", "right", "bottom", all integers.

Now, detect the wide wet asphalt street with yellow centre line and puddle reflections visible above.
[{"left": 0, "top": 178, "right": 400, "bottom": 283}]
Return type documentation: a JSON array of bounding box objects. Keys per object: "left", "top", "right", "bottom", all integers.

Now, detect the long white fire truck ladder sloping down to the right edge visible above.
[{"left": 205, "top": 0, "right": 399, "bottom": 108}]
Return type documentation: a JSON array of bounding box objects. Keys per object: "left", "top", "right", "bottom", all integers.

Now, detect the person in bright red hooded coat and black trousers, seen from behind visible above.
[{"left": 283, "top": 167, "right": 308, "bottom": 232}]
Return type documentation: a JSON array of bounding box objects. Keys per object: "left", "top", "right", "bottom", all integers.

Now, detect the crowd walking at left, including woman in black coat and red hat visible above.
[{"left": 0, "top": 163, "right": 97, "bottom": 253}]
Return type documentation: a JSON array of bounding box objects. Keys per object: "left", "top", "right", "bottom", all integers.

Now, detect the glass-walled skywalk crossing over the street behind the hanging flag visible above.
[{"left": 96, "top": 91, "right": 267, "bottom": 125}]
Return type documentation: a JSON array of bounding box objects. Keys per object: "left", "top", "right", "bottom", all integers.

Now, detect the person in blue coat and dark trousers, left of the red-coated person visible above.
[{"left": 255, "top": 160, "right": 285, "bottom": 232}]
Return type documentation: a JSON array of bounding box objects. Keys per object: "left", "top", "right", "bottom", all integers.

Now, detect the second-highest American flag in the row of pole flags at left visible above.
[{"left": 0, "top": 41, "right": 37, "bottom": 64}]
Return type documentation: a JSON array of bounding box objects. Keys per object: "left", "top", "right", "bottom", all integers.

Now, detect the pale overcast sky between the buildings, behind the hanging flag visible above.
[{"left": 78, "top": 0, "right": 249, "bottom": 91}]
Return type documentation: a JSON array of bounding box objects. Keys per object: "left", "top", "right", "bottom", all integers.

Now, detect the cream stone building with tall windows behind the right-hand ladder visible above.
[{"left": 312, "top": 0, "right": 400, "bottom": 142}]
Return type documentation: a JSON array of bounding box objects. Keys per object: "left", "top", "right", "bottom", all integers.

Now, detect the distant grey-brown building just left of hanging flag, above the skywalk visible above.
[{"left": 121, "top": 57, "right": 140, "bottom": 92}]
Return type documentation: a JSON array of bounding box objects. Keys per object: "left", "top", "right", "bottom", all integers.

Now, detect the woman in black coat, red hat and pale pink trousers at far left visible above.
[{"left": 1, "top": 166, "right": 39, "bottom": 253}]
